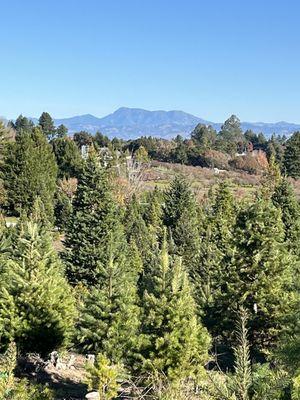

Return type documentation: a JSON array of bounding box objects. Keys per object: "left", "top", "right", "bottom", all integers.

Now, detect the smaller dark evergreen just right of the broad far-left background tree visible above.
[{"left": 51, "top": 137, "right": 82, "bottom": 179}]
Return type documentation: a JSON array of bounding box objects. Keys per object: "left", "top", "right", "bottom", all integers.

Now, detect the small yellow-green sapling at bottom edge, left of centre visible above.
[{"left": 86, "top": 354, "right": 122, "bottom": 400}]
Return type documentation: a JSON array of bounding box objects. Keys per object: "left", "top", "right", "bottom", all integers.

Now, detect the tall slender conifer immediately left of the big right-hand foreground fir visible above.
[{"left": 192, "top": 182, "right": 237, "bottom": 316}]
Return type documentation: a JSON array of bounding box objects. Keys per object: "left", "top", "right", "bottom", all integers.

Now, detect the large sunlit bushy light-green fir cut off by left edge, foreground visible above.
[{"left": 0, "top": 221, "right": 75, "bottom": 355}]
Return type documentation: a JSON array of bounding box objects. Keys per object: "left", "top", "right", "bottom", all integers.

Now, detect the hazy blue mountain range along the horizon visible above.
[{"left": 32, "top": 107, "right": 300, "bottom": 139}]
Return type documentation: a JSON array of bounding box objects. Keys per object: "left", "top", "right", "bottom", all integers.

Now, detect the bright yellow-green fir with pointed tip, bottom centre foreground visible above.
[{"left": 140, "top": 236, "right": 209, "bottom": 379}]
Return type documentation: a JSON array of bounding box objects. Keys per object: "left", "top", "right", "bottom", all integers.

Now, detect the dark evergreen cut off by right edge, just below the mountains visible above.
[{"left": 283, "top": 132, "right": 300, "bottom": 179}]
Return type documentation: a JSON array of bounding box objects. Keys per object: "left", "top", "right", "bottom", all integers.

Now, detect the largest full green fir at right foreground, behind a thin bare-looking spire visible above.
[{"left": 211, "top": 200, "right": 297, "bottom": 355}]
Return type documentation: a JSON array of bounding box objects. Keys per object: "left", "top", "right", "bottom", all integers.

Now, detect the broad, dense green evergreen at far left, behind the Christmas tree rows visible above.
[{"left": 2, "top": 128, "right": 57, "bottom": 220}]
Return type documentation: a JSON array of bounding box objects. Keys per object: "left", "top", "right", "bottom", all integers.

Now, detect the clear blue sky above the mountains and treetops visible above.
[{"left": 0, "top": 0, "right": 300, "bottom": 123}]
